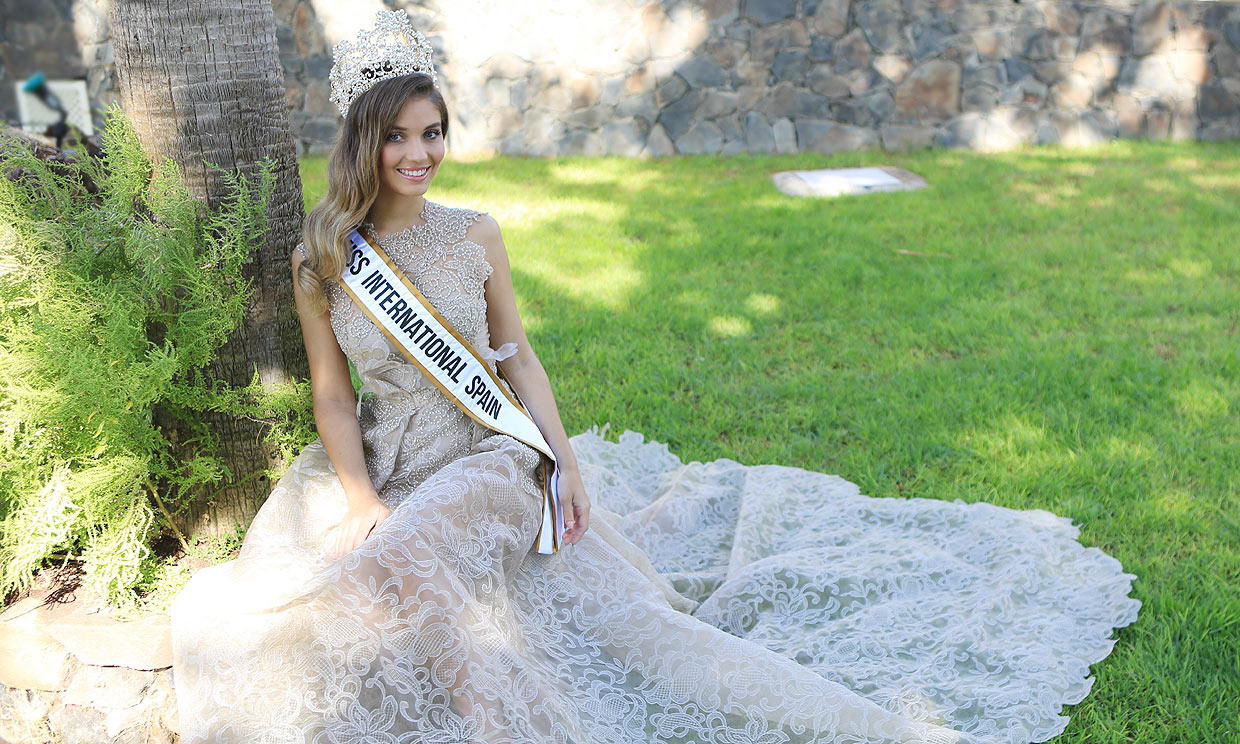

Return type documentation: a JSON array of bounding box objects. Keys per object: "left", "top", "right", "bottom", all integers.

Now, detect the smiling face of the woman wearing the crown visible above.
[{"left": 379, "top": 98, "right": 444, "bottom": 200}]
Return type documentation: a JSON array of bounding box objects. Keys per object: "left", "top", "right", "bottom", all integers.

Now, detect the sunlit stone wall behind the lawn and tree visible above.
[{"left": 0, "top": 0, "right": 1240, "bottom": 156}]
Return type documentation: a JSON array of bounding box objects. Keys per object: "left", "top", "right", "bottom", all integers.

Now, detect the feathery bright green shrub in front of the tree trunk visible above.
[{"left": 0, "top": 109, "right": 308, "bottom": 608}]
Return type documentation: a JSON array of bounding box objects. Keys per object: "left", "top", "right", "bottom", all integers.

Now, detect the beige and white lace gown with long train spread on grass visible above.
[{"left": 172, "top": 203, "right": 1138, "bottom": 744}]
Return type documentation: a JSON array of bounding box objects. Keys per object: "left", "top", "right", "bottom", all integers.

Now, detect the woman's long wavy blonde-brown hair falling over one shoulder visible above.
[{"left": 296, "top": 73, "right": 448, "bottom": 312}]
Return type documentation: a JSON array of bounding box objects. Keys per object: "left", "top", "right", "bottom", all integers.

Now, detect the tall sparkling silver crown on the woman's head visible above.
[{"left": 330, "top": 10, "right": 435, "bottom": 117}]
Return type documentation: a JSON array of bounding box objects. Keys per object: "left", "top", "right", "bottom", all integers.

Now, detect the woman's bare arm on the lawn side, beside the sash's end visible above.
[{"left": 470, "top": 215, "right": 590, "bottom": 544}]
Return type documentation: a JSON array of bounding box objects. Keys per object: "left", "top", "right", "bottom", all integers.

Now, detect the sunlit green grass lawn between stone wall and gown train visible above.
[{"left": 303, "top": 141, "right": 1240, "bottom": 744}]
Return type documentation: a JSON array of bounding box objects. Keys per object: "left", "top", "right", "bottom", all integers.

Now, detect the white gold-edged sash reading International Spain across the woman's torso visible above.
[{"left": 340, "top": 229, "right": 564, "bottom": 553}]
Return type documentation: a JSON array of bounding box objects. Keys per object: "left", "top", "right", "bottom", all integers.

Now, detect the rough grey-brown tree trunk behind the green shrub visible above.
[{"left": 112, "top": 0, "right": 308, "bottom": 534}]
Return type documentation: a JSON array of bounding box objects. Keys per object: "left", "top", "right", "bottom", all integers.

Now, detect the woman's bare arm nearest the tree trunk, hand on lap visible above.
[{"left": 293, "top": 250, "right": 391, "bottom": 558}]
